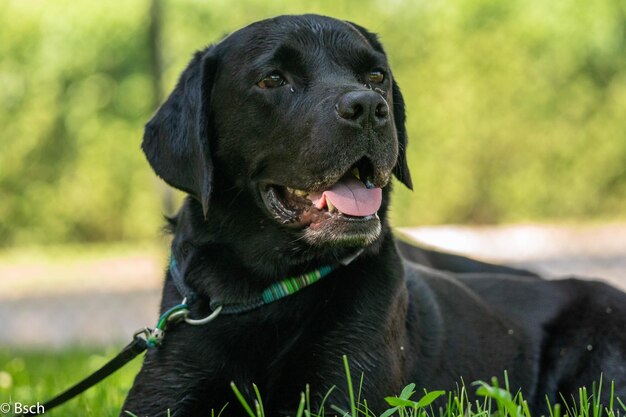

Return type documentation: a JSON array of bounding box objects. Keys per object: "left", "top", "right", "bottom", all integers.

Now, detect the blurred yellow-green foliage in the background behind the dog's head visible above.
[{"left": 0, "top": 0, "right": 626, "bottom": 246}]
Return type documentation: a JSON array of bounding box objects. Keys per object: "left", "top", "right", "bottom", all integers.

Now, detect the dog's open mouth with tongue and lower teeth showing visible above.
[{"left": 260, "top": 161, "right": 382, "bottom": 229}]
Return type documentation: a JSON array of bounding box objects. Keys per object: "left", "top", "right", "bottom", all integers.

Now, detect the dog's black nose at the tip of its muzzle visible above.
[{"left": 335, "top": 90, "right": 389, "bottom": 129}]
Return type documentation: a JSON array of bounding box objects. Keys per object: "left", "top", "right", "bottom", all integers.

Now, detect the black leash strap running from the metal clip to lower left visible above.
[{"left": 15, "top": 336, "right": 148, "bottom": 417}]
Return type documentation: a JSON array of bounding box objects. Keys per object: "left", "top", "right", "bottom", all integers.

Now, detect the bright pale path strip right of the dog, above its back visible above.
[{"left": 400, "top": 224, "right": 626, "bottom": 290}]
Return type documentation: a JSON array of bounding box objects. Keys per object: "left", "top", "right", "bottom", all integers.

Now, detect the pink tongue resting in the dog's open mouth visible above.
[{"left": 309, "top": 177, "right": 382, "bottom": 217}]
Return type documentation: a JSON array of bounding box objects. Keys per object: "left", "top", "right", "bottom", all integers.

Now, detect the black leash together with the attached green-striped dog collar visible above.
[{"left": 19, "top": 249, "right": 363, "bottom": 417}]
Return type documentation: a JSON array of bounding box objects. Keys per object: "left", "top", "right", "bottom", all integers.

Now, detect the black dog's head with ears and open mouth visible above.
[{"left": 142, "top": 15, "right": 411, "bottom": 254}]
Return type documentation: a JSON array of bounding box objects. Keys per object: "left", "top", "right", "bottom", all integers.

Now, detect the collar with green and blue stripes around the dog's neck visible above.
[{"left": 169, "top": 249, "right": 363, "bottom": 314}]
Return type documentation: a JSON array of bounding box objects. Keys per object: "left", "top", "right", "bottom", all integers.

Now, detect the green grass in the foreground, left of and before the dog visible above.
[{"left": 0, "top": 349, "right": 626, "bottom": 417}]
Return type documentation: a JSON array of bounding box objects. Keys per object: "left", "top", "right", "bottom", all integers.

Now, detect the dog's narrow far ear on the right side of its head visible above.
[{"left": 346, "top": 22, "right": 413, "bottom": 190}]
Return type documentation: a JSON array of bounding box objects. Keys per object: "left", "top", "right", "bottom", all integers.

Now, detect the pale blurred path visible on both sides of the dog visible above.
[{"left": 0, "top": 224, "right": 626, "bottom": 348}]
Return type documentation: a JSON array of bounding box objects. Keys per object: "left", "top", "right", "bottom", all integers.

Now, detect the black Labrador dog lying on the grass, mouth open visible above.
[{"left": 124, "top": 15, "right": 626, "bottom": 416}]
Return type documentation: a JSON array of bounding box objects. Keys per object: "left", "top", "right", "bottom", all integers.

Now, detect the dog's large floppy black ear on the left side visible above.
[{"left": 141, "top": 48, "right": 217, "bottom": 217}]
